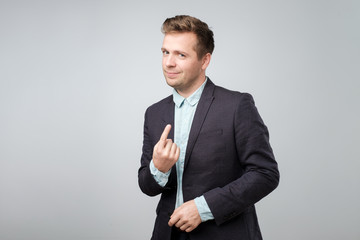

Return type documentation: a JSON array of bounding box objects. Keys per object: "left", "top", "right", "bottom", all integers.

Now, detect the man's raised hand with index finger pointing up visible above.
[{"left": 153, "top": 124, "right": 180, "bottom": 173}]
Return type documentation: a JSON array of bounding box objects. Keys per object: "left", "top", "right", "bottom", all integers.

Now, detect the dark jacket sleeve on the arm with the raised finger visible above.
[{"left": 138, "top": 109, "right": 174, "bottom": 196}]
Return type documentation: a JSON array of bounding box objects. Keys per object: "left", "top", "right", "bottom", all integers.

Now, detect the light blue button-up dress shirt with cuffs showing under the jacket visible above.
[{"left": 150, "top": 80, "right": 214, "bottom": 222}]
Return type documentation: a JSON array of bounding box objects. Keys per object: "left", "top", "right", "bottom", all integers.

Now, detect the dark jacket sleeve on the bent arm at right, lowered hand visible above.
[{"left": 204, "top": 93, "right": 279, "bottom": 225}]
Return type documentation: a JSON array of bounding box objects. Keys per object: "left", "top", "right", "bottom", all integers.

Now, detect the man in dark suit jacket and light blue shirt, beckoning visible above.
[{"left": 138, "top": 16, "right": 279, "bottom": 240}]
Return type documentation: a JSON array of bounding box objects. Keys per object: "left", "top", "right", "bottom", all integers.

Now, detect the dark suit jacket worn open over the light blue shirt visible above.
[{"left": 138, "top": 79, "right": 279, "bottom": 240}]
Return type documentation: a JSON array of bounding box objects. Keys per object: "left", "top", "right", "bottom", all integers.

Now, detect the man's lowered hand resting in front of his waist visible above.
[{"left": 168, "top": 200, "right": 201, "bottom": 232}]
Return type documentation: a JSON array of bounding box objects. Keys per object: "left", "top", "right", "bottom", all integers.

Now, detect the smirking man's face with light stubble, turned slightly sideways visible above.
[{"left": 161, "top": 32, "right": 210, "bottom": 97}]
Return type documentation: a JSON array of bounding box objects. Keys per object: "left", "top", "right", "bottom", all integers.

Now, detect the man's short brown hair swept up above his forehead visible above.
[{"left": 161, "top": 15, "right": 215, "bottom": 59}]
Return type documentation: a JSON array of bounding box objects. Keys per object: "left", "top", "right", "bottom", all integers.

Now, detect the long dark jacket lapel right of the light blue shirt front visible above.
[{"left": 184, "top": 79, "right": 215, "bottom": 168}]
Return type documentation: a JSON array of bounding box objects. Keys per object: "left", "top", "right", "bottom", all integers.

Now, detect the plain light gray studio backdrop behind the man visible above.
[{"left": 0, "top": 0, "right": 360, "bottom": 240}]
